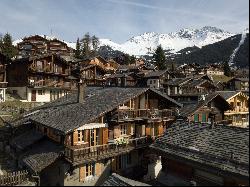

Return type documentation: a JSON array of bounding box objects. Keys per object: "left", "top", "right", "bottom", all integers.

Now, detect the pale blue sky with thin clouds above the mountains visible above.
[{"left": 0, "top": 0, "right": 249, "bottom": 43}]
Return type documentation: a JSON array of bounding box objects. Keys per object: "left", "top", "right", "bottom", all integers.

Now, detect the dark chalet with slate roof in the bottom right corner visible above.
[{"left": 150, "top": 122, "right": 249, "bottom": 186}]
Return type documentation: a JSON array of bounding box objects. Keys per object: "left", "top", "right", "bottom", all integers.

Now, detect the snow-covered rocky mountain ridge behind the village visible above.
[{"left": 100, "top": 26, "right": 235, "bottom": 55}]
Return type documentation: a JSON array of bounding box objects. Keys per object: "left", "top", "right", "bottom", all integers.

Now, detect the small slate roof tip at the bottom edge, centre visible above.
[{"left": 101, "top": 173, "right": 151, "bottom": 186}]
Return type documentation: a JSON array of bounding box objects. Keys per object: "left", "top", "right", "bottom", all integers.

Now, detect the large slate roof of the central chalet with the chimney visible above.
[{"left": 10, "top": 87, "right": 181, "bottom": 134}]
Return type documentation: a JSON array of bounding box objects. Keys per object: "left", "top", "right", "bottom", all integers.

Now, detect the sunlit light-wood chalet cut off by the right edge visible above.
[{"left": 217, "top": 91, "right": 249, "bottom": 127}]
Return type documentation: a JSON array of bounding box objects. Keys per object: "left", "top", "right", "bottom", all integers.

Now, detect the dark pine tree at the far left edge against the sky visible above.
[{"left": 0, "top": 33, "right": 18, "bottom": 58}]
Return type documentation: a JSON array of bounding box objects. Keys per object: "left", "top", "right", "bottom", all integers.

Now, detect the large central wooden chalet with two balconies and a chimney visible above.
[{"left": 6, "top": 86, "right": 181, "bottom": 185}]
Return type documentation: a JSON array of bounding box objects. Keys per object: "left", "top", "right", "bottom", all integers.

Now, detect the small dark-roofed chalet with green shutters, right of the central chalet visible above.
[{"left": 179, "top": 93, "right": 231, "bottom": 123}]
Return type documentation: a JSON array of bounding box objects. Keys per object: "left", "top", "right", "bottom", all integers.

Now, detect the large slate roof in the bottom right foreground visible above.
[{"left": 150, "top": 122, "right": 249, "bottom": 178}]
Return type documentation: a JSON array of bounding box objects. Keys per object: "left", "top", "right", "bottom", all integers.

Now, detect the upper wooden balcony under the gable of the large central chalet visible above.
[{"left": 111, "top": 109, "right": 174, "bottom": 122}]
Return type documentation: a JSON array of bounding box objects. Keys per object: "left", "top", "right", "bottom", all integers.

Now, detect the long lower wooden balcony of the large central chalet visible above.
[{"left": 65, "top": 137, "right": 154, "bottom": 164}]
